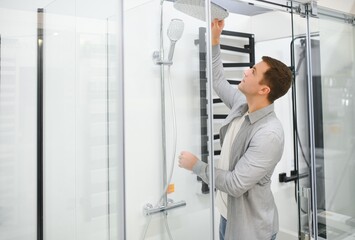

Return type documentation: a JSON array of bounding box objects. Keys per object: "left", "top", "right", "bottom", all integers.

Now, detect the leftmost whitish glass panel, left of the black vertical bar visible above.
[{"left": 0, "top": 1, "right": 37, "bottom": 240}]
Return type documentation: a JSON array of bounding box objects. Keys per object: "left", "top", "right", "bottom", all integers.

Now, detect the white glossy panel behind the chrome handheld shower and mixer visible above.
[{"left": 124, "top": 0, "right": 216, "bottom": 240}]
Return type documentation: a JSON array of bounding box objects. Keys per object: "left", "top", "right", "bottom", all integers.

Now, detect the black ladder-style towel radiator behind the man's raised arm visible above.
[{"left": 195, "top": 27, "right": 255, "bottom": 194}]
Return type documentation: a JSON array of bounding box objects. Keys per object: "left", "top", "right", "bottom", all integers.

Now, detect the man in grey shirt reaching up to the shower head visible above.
[{"left": 179, "top": 19, "right": 291, "bottom": 240}]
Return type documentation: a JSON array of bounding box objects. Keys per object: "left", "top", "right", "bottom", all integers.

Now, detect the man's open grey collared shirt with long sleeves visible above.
[{"left": 193, "top": 46, "right": 284, "bottom": 240}]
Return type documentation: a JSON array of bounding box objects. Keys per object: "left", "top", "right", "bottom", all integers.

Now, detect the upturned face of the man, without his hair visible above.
[{"left": 238, "top": 61, "right": 269, "bottom": 96}]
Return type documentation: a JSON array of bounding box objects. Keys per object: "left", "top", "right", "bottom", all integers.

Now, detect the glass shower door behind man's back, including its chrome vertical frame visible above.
[{"left": 295, "top": 6, "right": 355, "bottom": 240}]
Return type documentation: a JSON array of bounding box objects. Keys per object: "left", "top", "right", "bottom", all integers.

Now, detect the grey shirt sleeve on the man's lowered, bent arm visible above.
[{"left": 192, "top": 124, "right": 284, "bottom": 198}]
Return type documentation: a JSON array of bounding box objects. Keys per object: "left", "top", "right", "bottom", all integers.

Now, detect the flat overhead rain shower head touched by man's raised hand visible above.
[{"left": 174, "top": 0, "right": 229, "bottom": 21}]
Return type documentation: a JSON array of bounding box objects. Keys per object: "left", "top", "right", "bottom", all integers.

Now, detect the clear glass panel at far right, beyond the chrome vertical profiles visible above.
[{"left": 311, "top": 9, "right": 355, "bottom": 239}]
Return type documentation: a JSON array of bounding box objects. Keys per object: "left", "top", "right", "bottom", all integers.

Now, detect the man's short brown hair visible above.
[{"left": 260, "top": 56, "right": 292, "bottom": 103}]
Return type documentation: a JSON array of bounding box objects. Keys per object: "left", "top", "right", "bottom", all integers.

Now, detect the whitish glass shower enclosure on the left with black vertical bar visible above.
[{"left": 0, "top": 0, "right": 124, "bottom": 240}]
